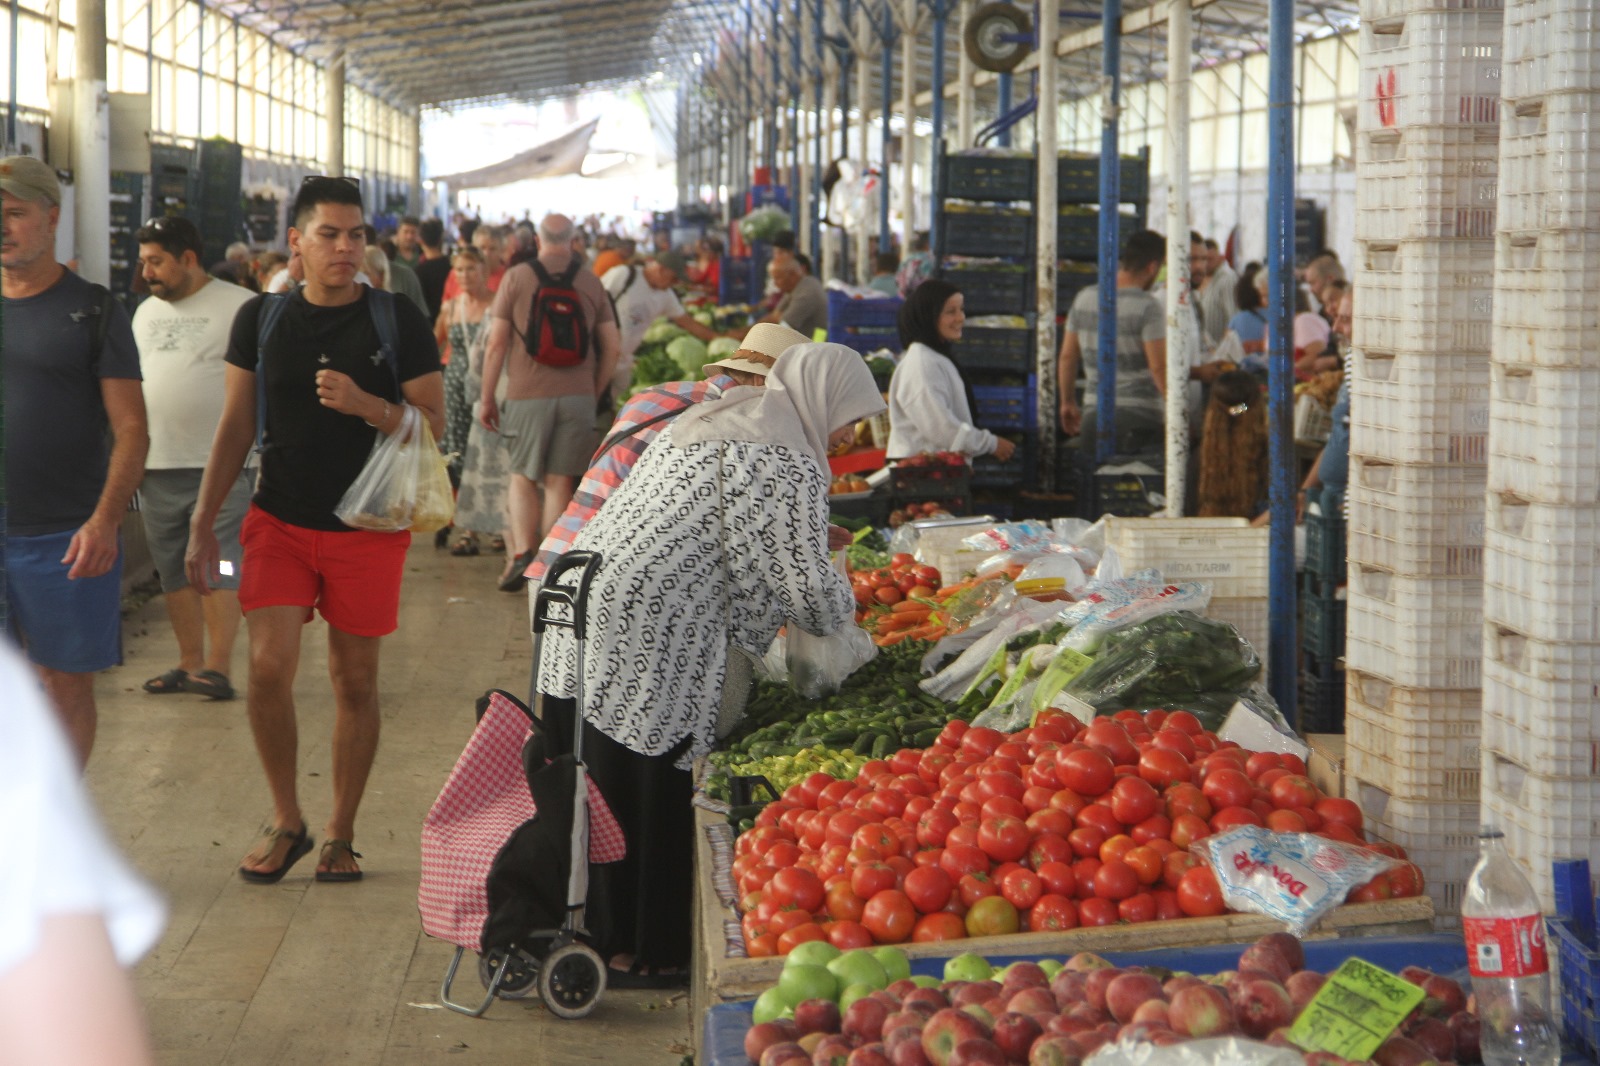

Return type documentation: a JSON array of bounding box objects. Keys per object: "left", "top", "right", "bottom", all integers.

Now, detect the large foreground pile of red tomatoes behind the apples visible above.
[{"left": 733, "top": 711, "right": 1422, "bottom": 957}]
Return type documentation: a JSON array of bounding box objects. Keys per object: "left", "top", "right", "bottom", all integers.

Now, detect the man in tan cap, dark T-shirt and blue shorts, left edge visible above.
[{"left": 0, "top": 155, "right": 150, "bottom": 763}]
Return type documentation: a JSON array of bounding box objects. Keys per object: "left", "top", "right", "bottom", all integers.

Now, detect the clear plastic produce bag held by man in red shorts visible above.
[{"left": 333, "top": 403, "right": 456, "bottom": 533}]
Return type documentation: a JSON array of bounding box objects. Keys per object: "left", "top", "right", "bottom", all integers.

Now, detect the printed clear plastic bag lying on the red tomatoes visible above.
[{"left": 1190, "top": 826, "right": 1398, "bottom": 938}]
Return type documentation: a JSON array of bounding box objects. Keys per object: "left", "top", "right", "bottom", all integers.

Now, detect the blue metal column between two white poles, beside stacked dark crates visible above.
[{"left": 1094, "top": 0, "right": 1120, "bottom": 464}]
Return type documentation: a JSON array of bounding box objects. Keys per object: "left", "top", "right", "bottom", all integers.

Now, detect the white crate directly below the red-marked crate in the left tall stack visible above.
[{"left": 1355, "top": 126, "right": 1499, "bottom": 240}]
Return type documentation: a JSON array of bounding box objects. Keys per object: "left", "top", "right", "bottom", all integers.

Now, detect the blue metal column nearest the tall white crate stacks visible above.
[{"left": 1267, "top": 0, "right": 1299, "bottom": 725}]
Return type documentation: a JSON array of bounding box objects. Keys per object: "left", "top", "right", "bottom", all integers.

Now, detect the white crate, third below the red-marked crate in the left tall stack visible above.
[{"left": 1350, "top": 347, "right": 1490, "bottom": 464}]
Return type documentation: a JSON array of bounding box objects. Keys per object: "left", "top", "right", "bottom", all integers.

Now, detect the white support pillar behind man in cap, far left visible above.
[{"left": 72, "top": 0, "right": 110, "bottom": 285}]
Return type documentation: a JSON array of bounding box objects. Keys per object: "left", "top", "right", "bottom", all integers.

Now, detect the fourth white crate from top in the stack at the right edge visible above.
[{"left": 1490, "top": 362, "right": 1600, "bottom": 506}]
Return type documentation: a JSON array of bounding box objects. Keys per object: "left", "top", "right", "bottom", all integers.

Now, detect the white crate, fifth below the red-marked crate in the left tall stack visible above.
[{"left": 1344, "top": 562, "right": 1483, "bottom": 688}]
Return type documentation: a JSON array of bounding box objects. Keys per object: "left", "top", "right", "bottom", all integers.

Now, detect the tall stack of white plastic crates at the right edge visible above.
[{"left": 1483, "top": 0, "right": 1600, "bottom": 908}]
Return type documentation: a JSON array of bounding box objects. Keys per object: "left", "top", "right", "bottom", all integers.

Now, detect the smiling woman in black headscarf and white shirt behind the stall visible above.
[{"left": 888, "top": 279, "right": 1016, "bottom": 463}]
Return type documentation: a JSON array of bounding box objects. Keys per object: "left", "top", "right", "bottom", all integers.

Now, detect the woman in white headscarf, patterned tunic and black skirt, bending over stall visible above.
[{"left": 538, "top": 344, "right": 883, "bottom": 986}]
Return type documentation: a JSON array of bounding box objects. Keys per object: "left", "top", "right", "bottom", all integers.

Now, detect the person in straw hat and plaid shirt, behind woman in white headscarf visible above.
[{"left": 526, "top": 320, "right": 810, "bottom": 585}]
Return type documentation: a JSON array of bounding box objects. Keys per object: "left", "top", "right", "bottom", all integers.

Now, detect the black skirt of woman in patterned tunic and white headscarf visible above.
[{"left": 542, "top": 695, "right": 694, "bottom": 968}]
